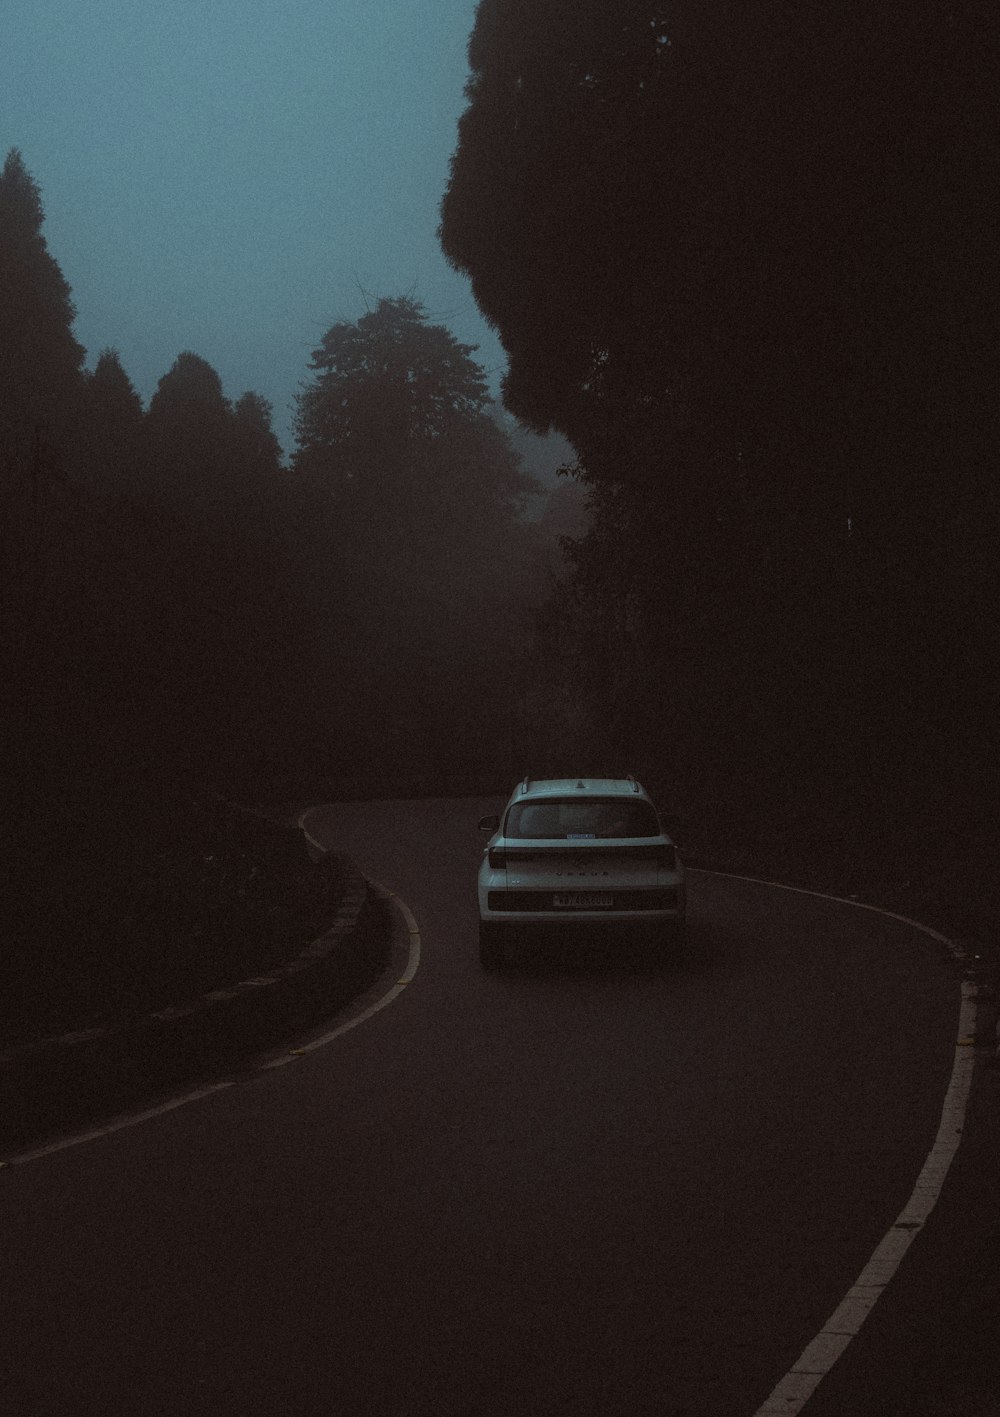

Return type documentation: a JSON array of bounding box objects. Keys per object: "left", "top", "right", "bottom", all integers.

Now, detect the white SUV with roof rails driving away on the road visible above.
[{"left": 479, "top": 777, "right": 686, "bottom": 969}]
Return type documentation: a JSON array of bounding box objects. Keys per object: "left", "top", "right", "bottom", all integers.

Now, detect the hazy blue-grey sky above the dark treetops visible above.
[{"left": 0, "top": 0, "right": 504, "bottom": 445}]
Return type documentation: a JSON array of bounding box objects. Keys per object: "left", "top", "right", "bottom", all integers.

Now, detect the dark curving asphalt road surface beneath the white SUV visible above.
[{"left": 0, "top": 799, "right": 958, "bottom": 1417}]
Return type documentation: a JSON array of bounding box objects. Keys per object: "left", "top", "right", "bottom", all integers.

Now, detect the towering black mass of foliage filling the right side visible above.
[{"left": 442, "top": 0, "right": 1000, "bottom": 828}]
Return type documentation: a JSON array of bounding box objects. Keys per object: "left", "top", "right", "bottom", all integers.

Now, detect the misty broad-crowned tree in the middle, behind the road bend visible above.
[{"left": 293, "top": 298, "right": 535, "bottom": 782}]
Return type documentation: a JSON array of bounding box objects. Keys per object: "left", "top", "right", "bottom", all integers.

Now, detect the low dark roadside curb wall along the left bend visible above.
[{"left": 0, "top": 852, "right": 390, "bottom": 1151}]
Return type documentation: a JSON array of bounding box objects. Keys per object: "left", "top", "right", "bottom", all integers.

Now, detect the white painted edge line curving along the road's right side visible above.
[{"left": 704, "top": 871, "right": 977, "bottom": 1417}]
